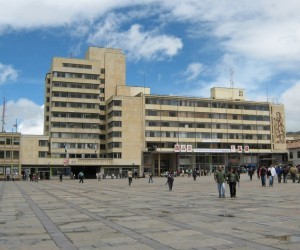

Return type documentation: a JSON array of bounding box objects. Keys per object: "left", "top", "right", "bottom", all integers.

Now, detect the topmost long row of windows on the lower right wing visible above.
[{"left": 146, "top": 98, "right": 269, "bottom": 111}]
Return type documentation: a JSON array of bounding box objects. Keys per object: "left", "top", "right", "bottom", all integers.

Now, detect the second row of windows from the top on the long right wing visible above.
[{"left": 146, "top": 109, "right": 270, "bottom": 121}]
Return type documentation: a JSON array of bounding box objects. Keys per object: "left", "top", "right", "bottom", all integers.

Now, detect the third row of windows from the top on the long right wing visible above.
[{"left": 146, "top": 121, "right": 270, "bottom": 131}]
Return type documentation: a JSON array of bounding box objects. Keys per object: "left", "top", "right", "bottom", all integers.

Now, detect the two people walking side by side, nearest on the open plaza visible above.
[{"left": 214, "top": 165, "right": 240, "bottom": 198}]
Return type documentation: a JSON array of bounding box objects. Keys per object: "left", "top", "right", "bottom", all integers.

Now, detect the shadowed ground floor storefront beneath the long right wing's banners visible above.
[{"left": 143, "top": 152, "right": 287, "bottom": 176}]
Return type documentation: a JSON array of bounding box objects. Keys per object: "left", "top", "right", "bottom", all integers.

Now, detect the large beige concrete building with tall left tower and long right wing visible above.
[{"left": 0, "top": 47, "right": 287, "bottom": 178}]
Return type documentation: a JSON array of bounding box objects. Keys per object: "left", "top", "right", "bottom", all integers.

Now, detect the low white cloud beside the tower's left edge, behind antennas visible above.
[{"left": 0, "top": 99, "right": 44, "bottom": 135}]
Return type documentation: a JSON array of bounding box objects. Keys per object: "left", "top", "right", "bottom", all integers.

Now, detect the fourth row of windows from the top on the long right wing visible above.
[{"left": 145, "top": 131, "right": 271, "bottom": 140}]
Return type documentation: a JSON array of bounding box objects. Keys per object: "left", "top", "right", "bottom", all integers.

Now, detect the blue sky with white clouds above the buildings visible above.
[{"left": 0, "top": 0, "right": 300, "bottom": 134}]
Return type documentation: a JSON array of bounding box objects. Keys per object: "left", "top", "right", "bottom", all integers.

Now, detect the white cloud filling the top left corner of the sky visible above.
[{"left": 0, "top": 0, "right": 146, "bottom": 31}]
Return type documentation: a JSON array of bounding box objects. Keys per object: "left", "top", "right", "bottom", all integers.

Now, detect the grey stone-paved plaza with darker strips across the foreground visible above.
[{"left": 0, "top": 175, "right": 300, "bottom": 250}]
